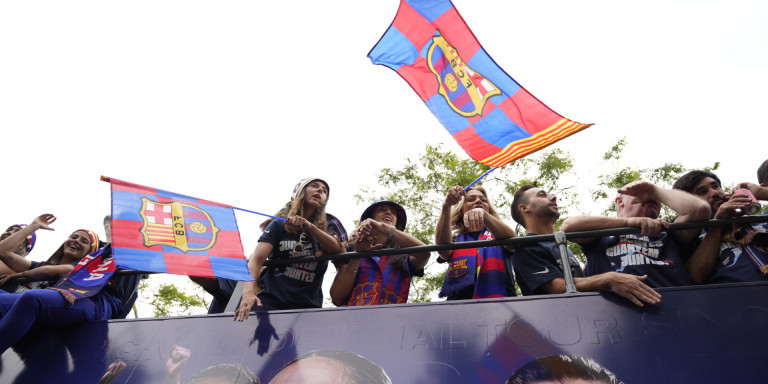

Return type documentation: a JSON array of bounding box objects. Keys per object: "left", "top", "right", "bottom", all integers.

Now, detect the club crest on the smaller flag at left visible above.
[{"left": 139, "top": 197, "right": 219, "bottom": 252}]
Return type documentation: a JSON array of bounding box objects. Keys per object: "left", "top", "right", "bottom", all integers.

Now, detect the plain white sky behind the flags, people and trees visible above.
[{"left": 0, "top": 0, "right": 768, "bottom": 312}]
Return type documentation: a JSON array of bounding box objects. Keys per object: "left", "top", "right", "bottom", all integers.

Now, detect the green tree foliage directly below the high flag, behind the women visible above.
[{"left": 356, "top": 144, "right": 576, "bottom": 302}]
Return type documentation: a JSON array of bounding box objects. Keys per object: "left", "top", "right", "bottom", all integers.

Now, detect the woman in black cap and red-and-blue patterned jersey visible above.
[{"left": 331, "top": 200, "right": 429, "bottom": 306}]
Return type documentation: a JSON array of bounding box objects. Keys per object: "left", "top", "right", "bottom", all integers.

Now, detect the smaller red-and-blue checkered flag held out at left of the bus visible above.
[{"left": 110, "top": 179, "right": 253, "bottom": 281}]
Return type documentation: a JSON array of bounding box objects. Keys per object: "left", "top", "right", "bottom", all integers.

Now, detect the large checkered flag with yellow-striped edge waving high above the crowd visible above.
[{"left": 368, "top": 0, "right": 590, "bottom": 167}]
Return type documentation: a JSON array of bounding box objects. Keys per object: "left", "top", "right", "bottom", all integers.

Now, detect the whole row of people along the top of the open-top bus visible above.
[{"left": 0, "top": 160, "right": 768, "bottom": 352}]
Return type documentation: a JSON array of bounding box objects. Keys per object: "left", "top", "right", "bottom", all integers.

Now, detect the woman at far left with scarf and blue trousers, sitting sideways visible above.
[{"left": 0, "top": 214, "right": 141, "bottom": 354}]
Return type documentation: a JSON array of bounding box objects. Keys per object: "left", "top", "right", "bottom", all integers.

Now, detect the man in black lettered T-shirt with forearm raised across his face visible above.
[{"left": 561, "top": 181, "right": 710, "bottom": 288}]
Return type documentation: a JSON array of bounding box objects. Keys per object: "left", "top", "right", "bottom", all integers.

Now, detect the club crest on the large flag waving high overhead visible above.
[{"left": 427, "top": 35, "right": 501, "bottom": 117}]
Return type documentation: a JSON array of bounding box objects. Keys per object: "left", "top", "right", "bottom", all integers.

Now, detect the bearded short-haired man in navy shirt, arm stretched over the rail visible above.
[{"left": 512, "top": 185, "right": 661, "bottom": 307}]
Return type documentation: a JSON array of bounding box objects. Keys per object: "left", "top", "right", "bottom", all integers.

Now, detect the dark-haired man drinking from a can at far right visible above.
[{"left": 673, "top": 170, "right": 768, "bottom": 284}]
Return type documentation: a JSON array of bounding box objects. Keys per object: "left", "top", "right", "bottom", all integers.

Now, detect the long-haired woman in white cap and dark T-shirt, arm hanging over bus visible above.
[{"left": 235, "top": 178, "right": 347, "bottom": 321}]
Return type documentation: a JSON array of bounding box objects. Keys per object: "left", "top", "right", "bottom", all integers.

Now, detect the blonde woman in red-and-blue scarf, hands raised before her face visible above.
[{"left": 435, "top": 186, "right": 517, "bottom": 300}]
